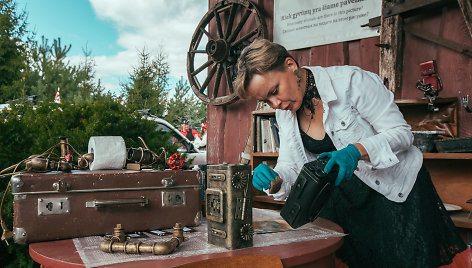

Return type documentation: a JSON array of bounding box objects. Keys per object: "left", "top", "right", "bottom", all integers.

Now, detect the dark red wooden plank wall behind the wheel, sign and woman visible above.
[{"left": 207, "top": 0, "right": 472, "bottom": 164}]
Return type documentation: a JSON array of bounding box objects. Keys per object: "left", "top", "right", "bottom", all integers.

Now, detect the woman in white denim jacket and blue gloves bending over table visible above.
[{"left": 234, "top": 39, "right": 467, "bottom": 267}]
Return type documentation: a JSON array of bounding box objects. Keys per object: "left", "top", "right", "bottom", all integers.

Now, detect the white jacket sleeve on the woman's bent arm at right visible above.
[{"left": 350, "top": 69, "right": 413, "bottom": 169}]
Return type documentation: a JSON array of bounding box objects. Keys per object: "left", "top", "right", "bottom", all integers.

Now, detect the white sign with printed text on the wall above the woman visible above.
[{"left": 274, "top": 0, "right": 382, "bottom": 50}]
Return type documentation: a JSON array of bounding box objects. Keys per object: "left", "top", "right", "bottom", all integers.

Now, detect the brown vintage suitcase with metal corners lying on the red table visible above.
[{"left": 11, "top": 170, "right": 201, "bottom": 244}]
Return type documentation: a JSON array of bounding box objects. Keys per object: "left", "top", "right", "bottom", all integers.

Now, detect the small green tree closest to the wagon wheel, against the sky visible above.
[{"left": 164, "top": 78, "right": 207, "bottom": 130}]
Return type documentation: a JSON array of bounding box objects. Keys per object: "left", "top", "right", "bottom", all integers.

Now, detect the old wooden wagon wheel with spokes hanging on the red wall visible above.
[{"left": 187, "top": 0, "right": 267, "bottom": 105}]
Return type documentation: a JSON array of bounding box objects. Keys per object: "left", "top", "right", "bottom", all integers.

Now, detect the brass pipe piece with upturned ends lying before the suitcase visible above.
[{"left": 100, "top": 223, "right": 185, "bottom": 255}]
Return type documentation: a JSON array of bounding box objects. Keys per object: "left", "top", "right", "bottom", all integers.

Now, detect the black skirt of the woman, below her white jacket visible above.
[{"left": 320, "top": 167, "right": 467, "bottom": 268}]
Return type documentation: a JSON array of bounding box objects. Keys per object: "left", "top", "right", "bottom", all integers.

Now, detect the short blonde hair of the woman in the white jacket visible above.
[{"left": 233, "top": 39, "right": 298, "bottom": 99}]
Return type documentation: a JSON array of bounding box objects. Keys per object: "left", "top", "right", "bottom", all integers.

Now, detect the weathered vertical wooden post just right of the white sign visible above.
[{"left": 379, "top": 0, "right": 403, "bottom": 92}]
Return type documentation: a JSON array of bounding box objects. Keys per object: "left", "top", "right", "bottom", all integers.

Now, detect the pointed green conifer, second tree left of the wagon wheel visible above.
[{"left": 121, "top": 48, "right": 169, "bottom": 118}]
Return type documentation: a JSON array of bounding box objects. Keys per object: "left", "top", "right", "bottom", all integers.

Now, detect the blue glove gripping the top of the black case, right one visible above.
[{"left": 318, "top": 144, "right": 361, "bottom": 186}]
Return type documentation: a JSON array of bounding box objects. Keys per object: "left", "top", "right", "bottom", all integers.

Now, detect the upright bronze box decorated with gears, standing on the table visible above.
[{"left": 205, "top": 164, "right": 254, "bottom": 249}]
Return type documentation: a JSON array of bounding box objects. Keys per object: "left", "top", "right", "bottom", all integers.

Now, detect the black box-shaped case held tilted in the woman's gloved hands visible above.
[{"left": 280, "top": 158, "right": 339, "bottom": 228}]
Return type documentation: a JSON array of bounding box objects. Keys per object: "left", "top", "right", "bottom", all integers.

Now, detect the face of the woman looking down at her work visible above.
[{"left": 247, "top": 58, "right": 304, "bottom": 111}]
